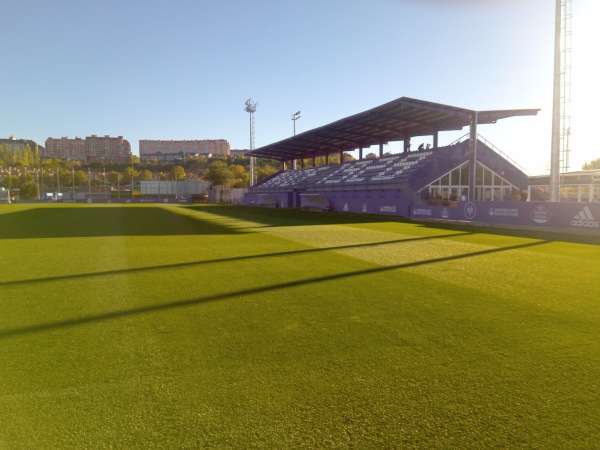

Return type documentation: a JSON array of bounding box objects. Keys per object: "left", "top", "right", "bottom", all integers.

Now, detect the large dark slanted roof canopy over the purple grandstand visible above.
[{"left": 248, "top": 97, "right": 539, "bottom": 161}]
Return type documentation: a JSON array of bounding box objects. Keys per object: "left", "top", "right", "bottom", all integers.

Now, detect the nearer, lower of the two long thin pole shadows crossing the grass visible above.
[{"left": 0, "top": 241, "right": 547, "bottom": 339}]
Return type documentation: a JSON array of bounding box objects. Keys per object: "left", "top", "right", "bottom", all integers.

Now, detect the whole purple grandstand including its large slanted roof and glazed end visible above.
[{"left": 246, "top": 97, "right": 538, "bottom": 216}]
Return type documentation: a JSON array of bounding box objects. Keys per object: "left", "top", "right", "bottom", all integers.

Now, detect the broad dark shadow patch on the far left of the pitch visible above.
[{"left": 0, "top": 205, "right": 243, "bottom": 239}]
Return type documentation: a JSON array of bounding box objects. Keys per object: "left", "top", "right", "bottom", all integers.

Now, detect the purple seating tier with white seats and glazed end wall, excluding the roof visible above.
[{"left": 246, "top": 139, "right": 527, "bottom": 215}]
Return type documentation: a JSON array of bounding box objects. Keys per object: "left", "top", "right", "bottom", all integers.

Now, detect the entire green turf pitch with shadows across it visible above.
[{"left": 0, "top": 205, "right": 600, "bottom": 449}]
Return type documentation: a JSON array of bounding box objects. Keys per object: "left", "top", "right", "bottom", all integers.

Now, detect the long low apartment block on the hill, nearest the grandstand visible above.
[{"left": 139, "top": 139, "right": 231, "bottom": 162}]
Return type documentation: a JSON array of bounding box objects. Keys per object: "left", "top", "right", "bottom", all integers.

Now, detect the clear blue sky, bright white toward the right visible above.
[{"left": 0, "top": 0, "right": 600, "bottom": 174}]
